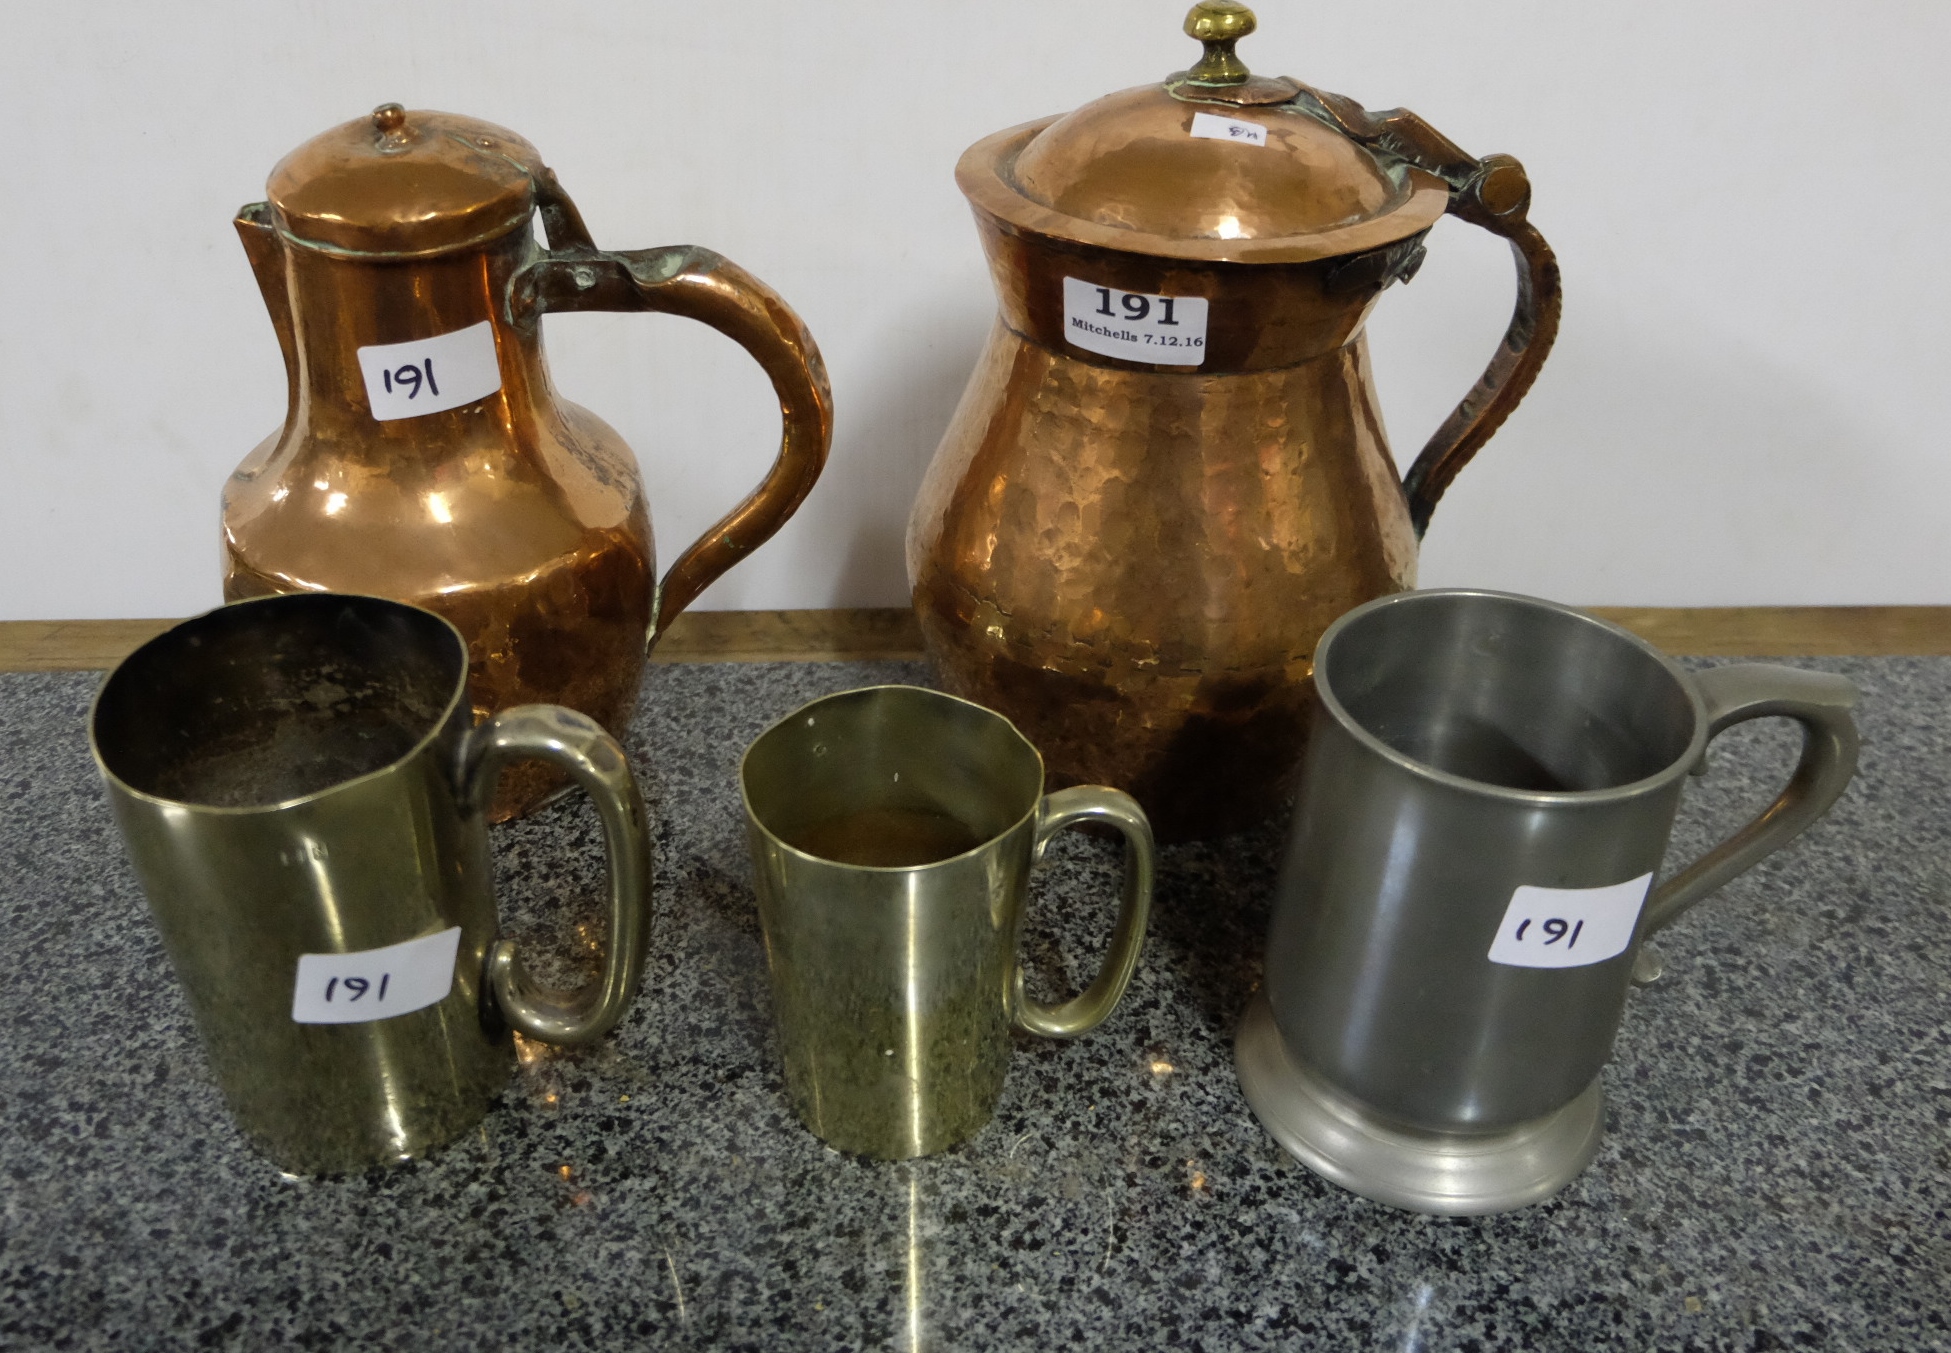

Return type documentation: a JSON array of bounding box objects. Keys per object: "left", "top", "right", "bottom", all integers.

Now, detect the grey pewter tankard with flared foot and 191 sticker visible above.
[{"left": 1237, "top": 592, "right": 1857, "bottom": 1214}]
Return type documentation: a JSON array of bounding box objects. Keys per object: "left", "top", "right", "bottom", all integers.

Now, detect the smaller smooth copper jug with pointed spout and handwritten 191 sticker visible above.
[{"left": 222, "top": 103, "right": 833, "bottom": 818}]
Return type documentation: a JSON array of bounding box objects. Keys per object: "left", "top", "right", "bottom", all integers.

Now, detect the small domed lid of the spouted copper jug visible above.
[{"left": 265, "top": 103, "right": 542, "bottom": 258}]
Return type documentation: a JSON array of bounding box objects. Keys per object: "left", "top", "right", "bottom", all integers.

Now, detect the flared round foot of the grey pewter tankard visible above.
[{"left": 1233, "top": 996, "right": 1606, "bottom": 1216}]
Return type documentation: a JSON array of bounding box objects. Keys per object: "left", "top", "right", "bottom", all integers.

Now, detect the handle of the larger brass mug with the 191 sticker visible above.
[{"left": 455, "top": 705, "right": 650, "bottom": 1045}]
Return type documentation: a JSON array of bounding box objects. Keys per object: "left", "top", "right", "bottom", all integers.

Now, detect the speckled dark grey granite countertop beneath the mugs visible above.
[{"left": 0, "top": 658, "right": 1951, "bottom": 1353}]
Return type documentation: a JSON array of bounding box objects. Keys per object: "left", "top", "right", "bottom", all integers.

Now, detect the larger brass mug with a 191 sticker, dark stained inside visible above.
[{"left": 88, "top": 594, "right": 650, "bottom": 1173}]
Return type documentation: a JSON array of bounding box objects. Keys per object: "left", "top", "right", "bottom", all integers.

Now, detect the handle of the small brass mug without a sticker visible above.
[{"left": 1009, "top": 785, "right": 1157, "bottom": 1039}]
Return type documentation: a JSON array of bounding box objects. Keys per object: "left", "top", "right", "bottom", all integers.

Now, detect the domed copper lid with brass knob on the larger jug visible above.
[{"left": 956, "top": 0, "right": 1450, "bottom": 264}]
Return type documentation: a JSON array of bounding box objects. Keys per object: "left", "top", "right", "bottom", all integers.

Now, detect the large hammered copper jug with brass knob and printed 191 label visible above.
[{"left": 907, "top": 0, "right": 1559, "bottom": 840}]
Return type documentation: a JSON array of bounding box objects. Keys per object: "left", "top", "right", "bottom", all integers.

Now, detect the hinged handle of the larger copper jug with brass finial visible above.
[{"left": 1294, "top": 86, "right": 1561, "bottom": 539}]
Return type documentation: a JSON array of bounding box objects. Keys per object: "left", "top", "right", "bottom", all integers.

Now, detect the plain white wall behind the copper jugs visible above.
[{"left": 0, "top": 0, "right": 1951, "bottom": 619}]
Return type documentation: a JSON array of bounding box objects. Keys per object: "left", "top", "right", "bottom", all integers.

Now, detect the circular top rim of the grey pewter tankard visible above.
[{"left": 1313, "top": 588, "right": 1707, "bottom": 806}]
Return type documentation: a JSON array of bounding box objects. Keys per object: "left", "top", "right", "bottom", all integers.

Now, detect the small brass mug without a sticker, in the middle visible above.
[{"left": 739, "top": 685, "right": 1155, "bottom": 1160}]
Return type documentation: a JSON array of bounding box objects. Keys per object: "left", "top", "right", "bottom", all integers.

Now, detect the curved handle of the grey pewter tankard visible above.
[{"left": 1641, "top": 662, "right": 1861, "bottom": 941}]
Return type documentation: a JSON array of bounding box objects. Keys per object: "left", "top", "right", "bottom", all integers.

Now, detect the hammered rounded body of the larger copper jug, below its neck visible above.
[{"left": 909, "top": 324, "right": 1416, "bottom": 838}]
